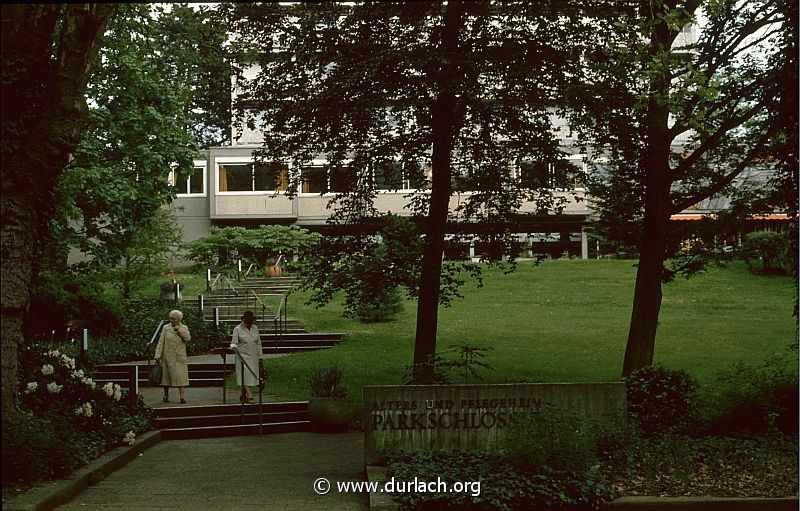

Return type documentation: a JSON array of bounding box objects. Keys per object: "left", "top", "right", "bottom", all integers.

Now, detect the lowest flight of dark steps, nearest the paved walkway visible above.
[{"left": 153, "top": 401, "right": 309, "bottom": 440}]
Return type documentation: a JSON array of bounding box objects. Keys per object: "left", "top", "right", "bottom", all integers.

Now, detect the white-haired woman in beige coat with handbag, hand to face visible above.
[{"left": 155, "top": 310, "right": 192, "bottom": 403}]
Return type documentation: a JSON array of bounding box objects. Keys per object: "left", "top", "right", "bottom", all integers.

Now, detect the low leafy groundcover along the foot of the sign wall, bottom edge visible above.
[{"left": 388, "top": 451, "right": 611, "bottom": 510}]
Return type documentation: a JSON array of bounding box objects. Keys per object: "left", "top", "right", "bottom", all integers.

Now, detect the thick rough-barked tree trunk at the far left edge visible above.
[{"left": 0, "top": 4, "right": 116, "bottom": 419}]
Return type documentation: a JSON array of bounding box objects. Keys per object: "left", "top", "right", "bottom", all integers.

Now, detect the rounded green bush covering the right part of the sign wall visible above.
[{"left": 500, "top": 404, "right": 597, "bottom": 474}]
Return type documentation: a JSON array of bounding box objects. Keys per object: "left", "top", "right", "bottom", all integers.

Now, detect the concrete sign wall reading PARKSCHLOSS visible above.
[{"left": 362, "top": 383, "right": 625, "bottom": 465}]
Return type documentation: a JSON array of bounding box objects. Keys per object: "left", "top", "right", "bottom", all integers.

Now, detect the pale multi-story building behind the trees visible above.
[{"left": 170, "top": 18, "right": 788, "bottom": 258}]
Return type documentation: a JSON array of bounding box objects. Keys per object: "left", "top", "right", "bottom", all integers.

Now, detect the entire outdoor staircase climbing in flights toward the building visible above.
[{"left": 94, "top": 277, "right": 342, "bottom": 440}]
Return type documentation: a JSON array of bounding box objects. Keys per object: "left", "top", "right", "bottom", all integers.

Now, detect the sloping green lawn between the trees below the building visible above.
[{"left": 260, "top": 260, "right": 796, "bottom": 408}]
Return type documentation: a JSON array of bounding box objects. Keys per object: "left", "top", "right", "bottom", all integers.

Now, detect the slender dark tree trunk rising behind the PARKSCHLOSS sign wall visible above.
[{"left": 414, "top": 2, "right": 464, "bottom": 383}]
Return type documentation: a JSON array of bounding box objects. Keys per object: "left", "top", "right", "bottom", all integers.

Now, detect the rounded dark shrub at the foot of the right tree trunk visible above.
[{"left": 625, "top": 364, "right": 697, "bottom": 436}]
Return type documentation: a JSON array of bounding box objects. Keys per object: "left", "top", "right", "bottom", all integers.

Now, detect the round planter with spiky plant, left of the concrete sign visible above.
[{"left": 308, "top": 364, "right": 353, "bottom": 433}]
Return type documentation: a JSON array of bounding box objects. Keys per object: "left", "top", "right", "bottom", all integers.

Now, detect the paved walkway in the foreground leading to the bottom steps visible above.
[{"left": 56, "top": 433, "right": 369, "bottom": 511}]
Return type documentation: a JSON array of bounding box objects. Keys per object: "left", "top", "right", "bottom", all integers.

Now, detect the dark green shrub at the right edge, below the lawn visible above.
[{"left": 704, "top": 357, "right": 798, "bottom": 437}]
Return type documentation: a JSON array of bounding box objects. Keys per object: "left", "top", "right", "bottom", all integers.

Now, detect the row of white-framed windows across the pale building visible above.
[{"left": 170, "top": 160, "right": 585, "bottom": 196}]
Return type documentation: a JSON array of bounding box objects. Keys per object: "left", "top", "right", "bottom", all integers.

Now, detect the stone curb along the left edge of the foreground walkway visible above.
[{"left": 3, "top": 430, "right": 163, "bottom": 511}]
